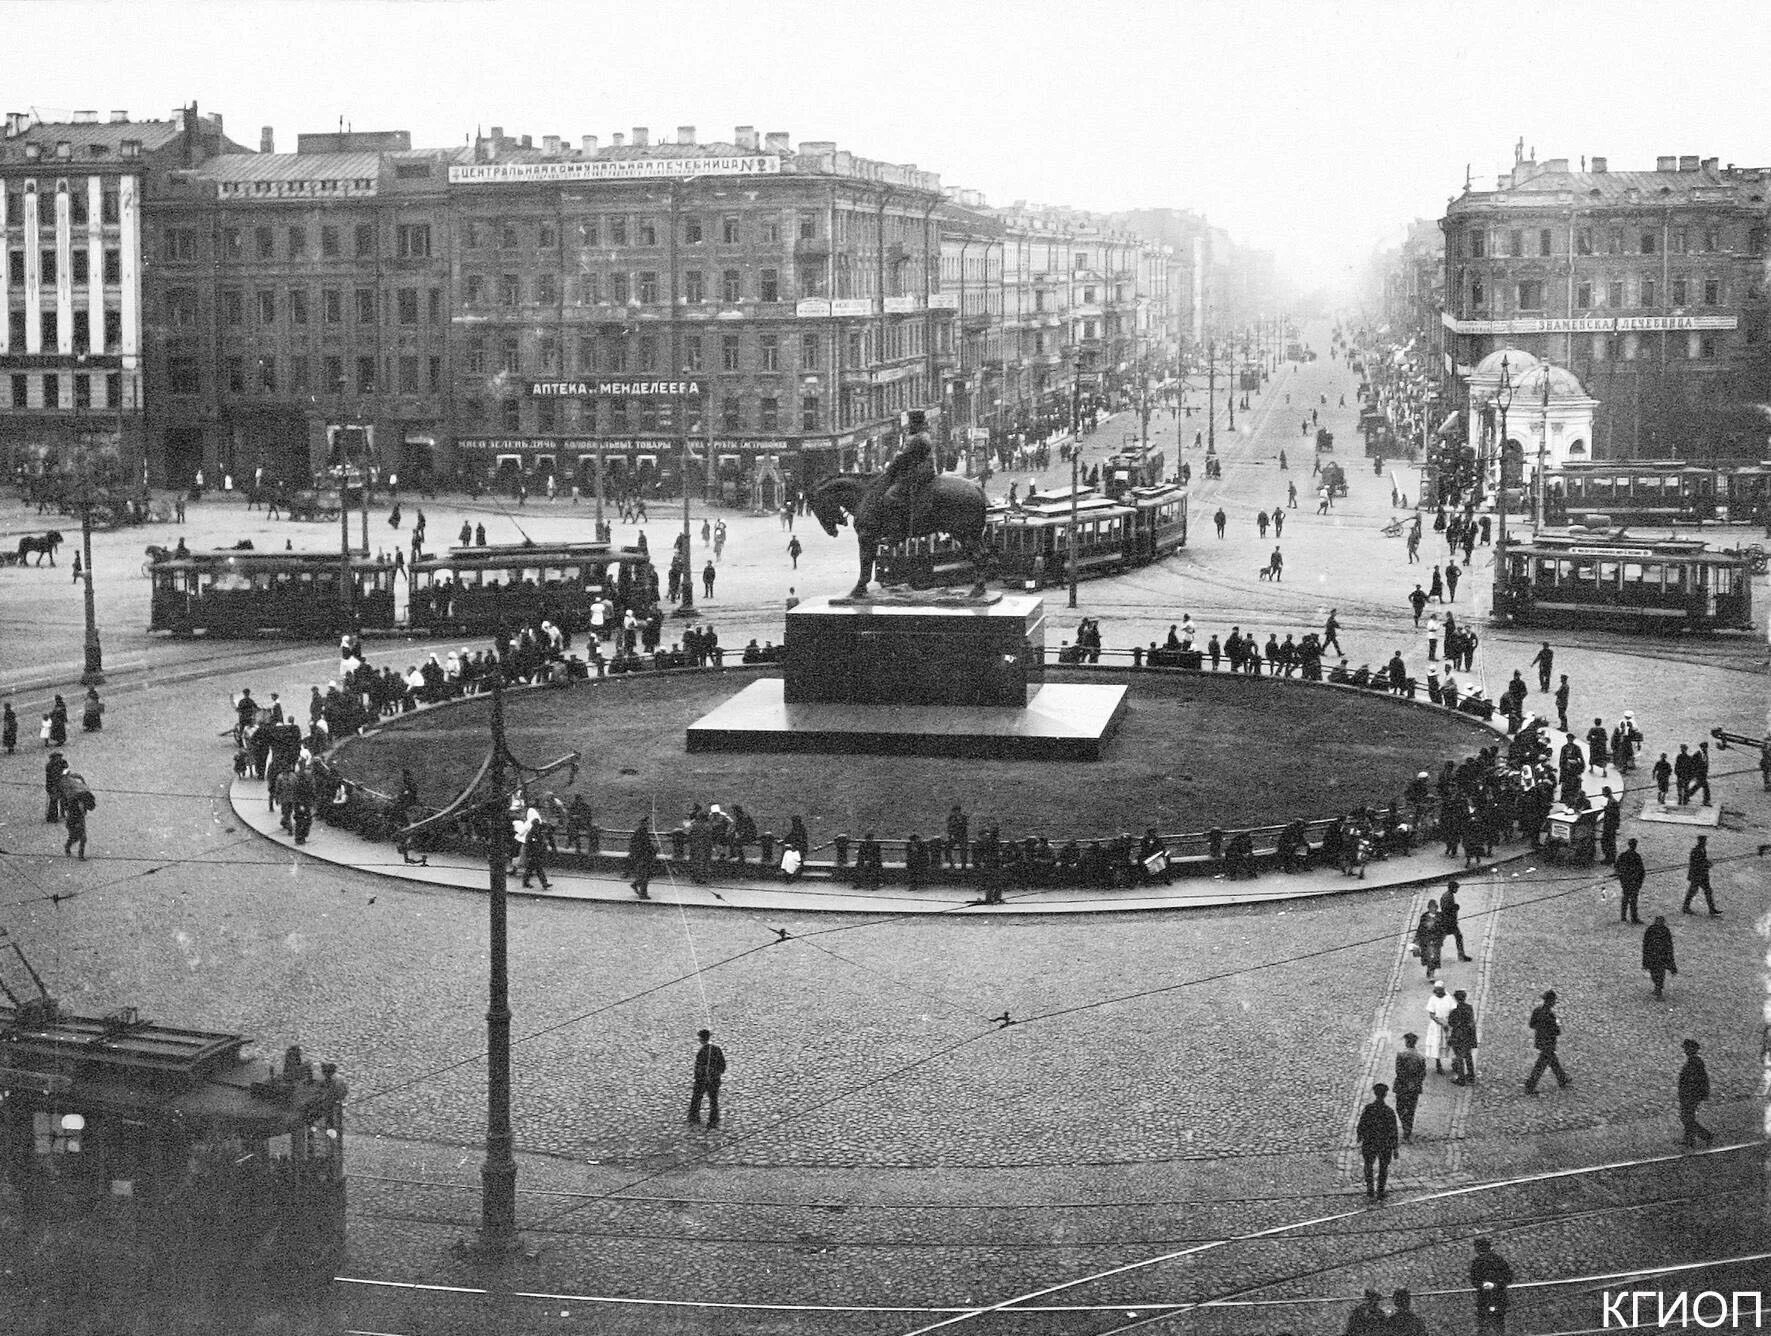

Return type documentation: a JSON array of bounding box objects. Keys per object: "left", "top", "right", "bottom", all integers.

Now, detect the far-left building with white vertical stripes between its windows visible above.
[{"left": 0, "top": 106, "right": 237, "bottom": 478}]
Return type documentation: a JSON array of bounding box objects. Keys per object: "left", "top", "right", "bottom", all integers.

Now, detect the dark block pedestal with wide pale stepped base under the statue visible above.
[{"left": 687, "top": 594, "right": 1126, "bottom": 760}]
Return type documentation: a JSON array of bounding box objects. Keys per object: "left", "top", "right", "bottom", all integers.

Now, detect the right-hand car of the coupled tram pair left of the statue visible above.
[{"left": 407, "top": 542, "right": 659, "bottom": 633}]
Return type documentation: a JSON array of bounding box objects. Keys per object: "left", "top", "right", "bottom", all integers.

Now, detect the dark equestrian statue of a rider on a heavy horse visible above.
[{"left": 806, "top": 409, "right": 990, "bottom": 599}]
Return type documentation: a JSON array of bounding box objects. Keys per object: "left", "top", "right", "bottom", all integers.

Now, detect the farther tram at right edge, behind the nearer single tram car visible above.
[{"left": 1544, "top": 459, "right": 1771, "bottom": 524}]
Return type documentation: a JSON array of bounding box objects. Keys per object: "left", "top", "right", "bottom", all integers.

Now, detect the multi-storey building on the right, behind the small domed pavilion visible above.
[{"left": 1440, "top": 156, "right": 1771, "bottom": 459}]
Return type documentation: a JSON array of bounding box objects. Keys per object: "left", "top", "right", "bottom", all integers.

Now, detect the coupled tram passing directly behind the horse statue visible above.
[{"left": 877, "top": 484, "right": 1187, "bottom": 590}]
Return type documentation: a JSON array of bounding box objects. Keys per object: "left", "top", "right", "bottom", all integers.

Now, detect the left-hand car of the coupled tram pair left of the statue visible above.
[{"left": 147, "top": 551, "right": 398, "bottom": 638}]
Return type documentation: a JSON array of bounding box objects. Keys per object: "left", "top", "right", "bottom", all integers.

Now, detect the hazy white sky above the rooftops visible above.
[{"left": 0, "top": 0, "right": 1771, "bottom": 294}]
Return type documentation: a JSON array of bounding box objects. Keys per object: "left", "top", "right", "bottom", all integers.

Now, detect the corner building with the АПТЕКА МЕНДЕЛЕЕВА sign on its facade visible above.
[{"left": 448, "top": 126, "right": 958, "bottom": 507}]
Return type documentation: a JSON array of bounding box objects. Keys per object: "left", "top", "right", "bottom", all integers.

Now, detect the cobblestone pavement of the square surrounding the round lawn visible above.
[{"left": 0, "top": 326, "right": 1771, "bottom": 1334}]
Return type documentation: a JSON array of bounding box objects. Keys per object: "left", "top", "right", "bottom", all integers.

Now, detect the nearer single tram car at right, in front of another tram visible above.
[{"left": 1495, "top": 530, "right": 1753, "bottom": 634}]
